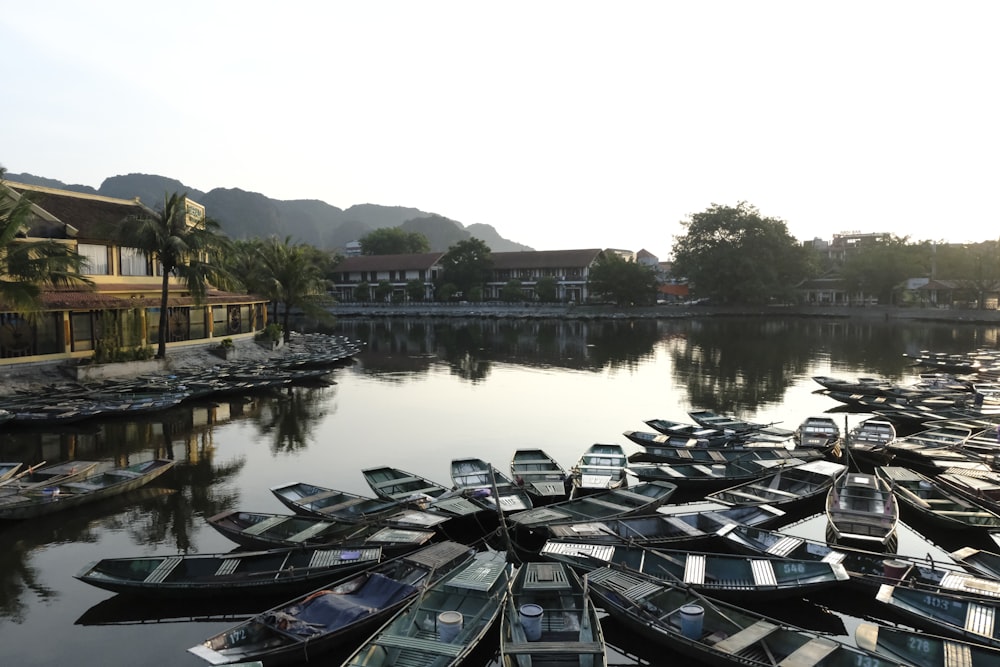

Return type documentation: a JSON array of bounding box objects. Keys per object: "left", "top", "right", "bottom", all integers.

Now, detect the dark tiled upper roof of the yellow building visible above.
[{"left": 5, "top": 181, "right": 149, "bottom": 241}]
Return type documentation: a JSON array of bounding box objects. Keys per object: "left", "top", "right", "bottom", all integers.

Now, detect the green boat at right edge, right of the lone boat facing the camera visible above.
[{"left": 875, "top": 466, "right": 1000, "bottom": 530}]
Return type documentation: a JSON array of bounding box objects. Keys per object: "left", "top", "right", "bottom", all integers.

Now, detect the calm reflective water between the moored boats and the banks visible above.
[{"left": 0, "top": 319, "right": 998, "bottom": 666}]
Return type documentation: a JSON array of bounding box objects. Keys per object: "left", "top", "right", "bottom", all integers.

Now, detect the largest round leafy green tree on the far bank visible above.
[{"left": 673, "top": 202, "right": 815, "bottom": 303}]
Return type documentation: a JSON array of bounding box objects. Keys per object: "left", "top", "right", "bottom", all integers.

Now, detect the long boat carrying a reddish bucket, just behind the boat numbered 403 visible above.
[{"left": 722, "top": 525, "right": 1000, "bottom": 597}]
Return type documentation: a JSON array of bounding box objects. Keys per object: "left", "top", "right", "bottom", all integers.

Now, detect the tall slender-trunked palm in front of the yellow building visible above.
[{"left": 114, "top": 192, "right": 227, "bottom": 359}]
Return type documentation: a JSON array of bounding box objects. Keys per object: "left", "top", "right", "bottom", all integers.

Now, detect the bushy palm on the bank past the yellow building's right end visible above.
[{"left": 257, "top": 236, "right": 331, "bottom": 343}]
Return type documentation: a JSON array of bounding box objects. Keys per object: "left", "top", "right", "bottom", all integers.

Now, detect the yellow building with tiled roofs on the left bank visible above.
[{"left": 0, "top": 181, "right": 267, "bottom": 365}]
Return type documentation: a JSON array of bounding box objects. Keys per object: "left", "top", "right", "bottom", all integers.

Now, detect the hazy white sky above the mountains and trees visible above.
[{"left": 0, "top": 0, "right": 1000, "bottom": 259}]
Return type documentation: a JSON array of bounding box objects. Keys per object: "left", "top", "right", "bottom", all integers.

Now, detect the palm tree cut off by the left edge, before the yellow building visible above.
[{"left": 0, "top": 167, "right": 93, "bottom": 311}]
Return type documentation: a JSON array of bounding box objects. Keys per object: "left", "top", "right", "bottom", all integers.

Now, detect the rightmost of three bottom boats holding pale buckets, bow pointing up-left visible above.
[{"left": 587, "top": 567, "right": 898, "bottom": 667}]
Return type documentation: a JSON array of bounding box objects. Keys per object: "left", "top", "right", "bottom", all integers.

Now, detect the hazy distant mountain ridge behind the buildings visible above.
[{"left": 6, "top": 174, "right": 533, "bottom": 252}]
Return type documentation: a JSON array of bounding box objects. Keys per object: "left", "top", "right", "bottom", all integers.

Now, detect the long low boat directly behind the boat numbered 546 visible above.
[{"left": 543, "top": 505, "right": 785, "bottom": 549}]
